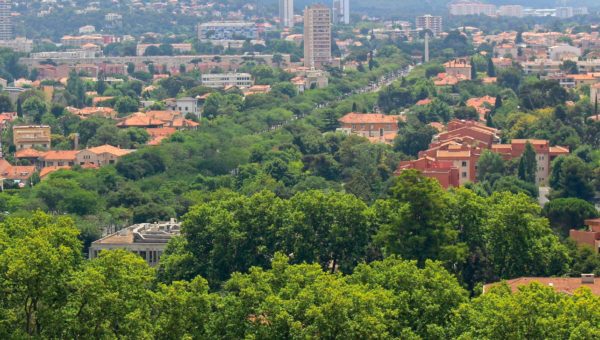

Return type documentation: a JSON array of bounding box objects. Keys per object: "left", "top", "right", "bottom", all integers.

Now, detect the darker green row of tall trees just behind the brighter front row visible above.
[{"left": 159, "top": 170, "right": 600, "bottom": 290}]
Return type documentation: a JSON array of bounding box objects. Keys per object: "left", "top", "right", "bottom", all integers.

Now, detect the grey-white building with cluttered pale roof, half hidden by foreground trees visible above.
[{"left": 89, "top": 219, "right": 181, "bottom": 266}]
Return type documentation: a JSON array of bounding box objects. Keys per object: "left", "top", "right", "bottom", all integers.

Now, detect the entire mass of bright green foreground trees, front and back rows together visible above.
[{"left": 0, "top": 181, "right": 600, "bottom": 339}]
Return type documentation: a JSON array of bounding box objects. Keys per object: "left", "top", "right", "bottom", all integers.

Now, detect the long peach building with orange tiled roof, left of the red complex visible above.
[{"left": 338, "top": 112, "right": 402, "bottom": 143}]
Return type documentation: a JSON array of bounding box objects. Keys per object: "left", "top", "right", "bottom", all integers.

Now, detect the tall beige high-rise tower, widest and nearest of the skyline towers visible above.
[{"left": 304, "top": 5, "right": 331, "bottom": 68}]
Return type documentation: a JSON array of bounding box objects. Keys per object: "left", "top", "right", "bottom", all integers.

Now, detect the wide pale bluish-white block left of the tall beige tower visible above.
[{"left": 198, "top": 21, "right": 258, "bottom": 40}]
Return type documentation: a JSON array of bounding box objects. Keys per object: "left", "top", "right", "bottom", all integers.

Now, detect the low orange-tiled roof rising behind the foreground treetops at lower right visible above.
[{"left": 483, "top": 274, "right": 600, "bottom": 295}]
